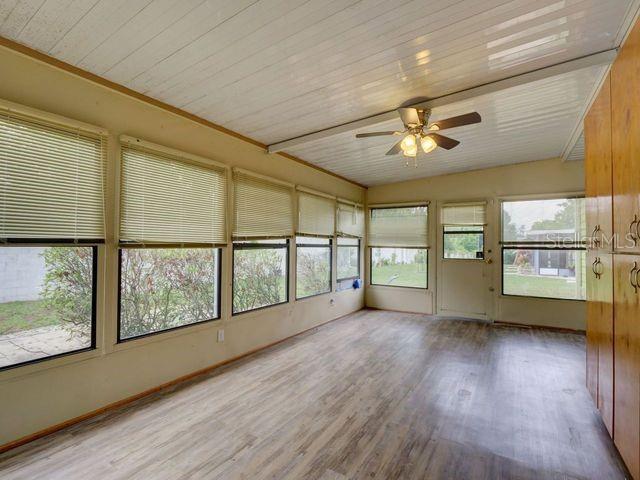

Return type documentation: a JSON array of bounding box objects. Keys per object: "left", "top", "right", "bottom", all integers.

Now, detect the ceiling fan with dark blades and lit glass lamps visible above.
[{"left": 356, "top": 108, "right": 482, "bottom": 165}]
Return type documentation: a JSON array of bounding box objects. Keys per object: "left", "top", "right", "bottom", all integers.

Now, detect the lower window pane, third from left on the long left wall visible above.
[{"left": 233, "top": 239, "right": 289, "bottom": 315}]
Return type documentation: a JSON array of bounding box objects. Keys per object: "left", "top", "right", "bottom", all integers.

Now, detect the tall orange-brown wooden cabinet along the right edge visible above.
[{"left": 584, "top": 15, "right": 640, "bottom": 480}]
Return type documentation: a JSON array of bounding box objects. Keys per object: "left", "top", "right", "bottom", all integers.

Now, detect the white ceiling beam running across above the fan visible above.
[{"left": 267, "top": 48, "right": 618, "bottom": 153}]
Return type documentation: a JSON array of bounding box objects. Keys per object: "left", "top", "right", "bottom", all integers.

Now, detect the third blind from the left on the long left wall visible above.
[{"left": 233, "top": 170, "right": 293, "bottom": 239}]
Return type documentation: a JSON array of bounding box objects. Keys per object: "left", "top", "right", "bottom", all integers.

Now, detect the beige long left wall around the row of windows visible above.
[{"left": 0, "top": 48, "right": 364, "bottom": 444}]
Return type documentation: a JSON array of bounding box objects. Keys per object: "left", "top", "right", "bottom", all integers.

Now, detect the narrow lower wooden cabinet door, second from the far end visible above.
[{"left": 591, "top": 253, "right": 613, "bottom": 436}]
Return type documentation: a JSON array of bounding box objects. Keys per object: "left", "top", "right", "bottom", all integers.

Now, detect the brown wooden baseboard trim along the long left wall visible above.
[{"left": 0, "top": 307, "right": 366, "bottom": 454}]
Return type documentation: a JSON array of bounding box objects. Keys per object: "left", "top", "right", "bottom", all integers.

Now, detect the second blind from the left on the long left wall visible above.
[{"left": 120, "top": 145, "right": 227, "bottom": 244}]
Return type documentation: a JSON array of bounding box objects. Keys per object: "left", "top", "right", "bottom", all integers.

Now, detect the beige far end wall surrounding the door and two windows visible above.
[{"left": 366, "top": 159, "right": 586, "bottom": 330}]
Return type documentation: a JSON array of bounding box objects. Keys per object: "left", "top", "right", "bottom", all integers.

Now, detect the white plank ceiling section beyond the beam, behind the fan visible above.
[{"left": 288, "top": 66, "right": 606, "bottom": 185}]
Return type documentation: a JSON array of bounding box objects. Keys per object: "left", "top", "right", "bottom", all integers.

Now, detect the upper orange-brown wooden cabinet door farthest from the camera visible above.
[{"left": 584, "top": 75, "right": 613, "bottom": 250}]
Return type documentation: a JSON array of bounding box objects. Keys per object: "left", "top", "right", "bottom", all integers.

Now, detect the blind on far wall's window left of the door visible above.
[{"left": 368, "top": 205, "right": 428, "bottom": 248}]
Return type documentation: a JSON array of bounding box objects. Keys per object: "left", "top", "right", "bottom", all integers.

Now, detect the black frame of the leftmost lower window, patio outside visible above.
[{"left": 0, "top": 244, "right": 98, "bottom": 372}]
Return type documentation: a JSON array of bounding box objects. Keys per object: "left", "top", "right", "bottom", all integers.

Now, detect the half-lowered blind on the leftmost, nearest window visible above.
[{"left": 0, "top": 111, "right": 106, "bottom": 241}]
